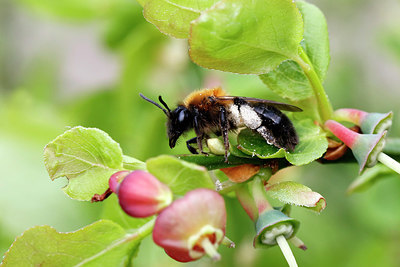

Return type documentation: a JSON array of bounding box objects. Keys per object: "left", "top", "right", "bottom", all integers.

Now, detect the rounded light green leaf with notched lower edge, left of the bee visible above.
[{"left": 44, "top": 126, "right": 123, "bottom": 200}]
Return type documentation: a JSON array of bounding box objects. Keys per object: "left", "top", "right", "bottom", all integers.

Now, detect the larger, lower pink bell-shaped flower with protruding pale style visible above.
[{"left": 153, "top": 188, "right": 226, "bottom": 262}]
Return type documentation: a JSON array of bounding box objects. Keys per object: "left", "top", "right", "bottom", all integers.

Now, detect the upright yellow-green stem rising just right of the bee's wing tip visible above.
[{"left": 296, "top": 46, "right": 333, "bottom": 123}]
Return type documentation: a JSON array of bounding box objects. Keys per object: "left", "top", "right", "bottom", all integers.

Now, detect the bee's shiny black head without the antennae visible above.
[{"left": 167, "top": 106, "right": 193, "bottom": 148}]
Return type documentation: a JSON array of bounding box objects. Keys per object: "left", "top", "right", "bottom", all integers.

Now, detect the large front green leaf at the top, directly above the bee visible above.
[{"left": 189, "top": 0, "right": 303, "bottom": 74}]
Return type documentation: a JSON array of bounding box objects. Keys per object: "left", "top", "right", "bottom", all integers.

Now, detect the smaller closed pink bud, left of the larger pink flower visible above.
[{"left": 117, "top": 170, "right": 172, "bottom": 218}]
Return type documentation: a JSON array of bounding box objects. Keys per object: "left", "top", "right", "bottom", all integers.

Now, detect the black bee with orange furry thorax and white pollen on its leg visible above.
[{"left": 140, "top": 87, "right": 302, "bottom": 162}]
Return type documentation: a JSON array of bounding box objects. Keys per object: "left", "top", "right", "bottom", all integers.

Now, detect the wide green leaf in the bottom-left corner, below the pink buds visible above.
[{"left": 2, "top": 220, "right": 138, "bottom": 266}]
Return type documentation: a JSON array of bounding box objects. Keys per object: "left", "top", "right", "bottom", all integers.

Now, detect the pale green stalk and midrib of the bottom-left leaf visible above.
[{"left": 75, "top": 218, "right": 156, "bottom": 267}]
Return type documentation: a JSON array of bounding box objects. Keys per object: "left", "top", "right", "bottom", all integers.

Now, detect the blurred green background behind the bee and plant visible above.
[{"left": 0, "top": 0, "right": 400, "bottom": 266}]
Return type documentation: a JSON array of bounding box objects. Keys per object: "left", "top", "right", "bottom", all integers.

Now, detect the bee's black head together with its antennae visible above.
[{"left": 139, "top": 94, "right": 192, "bottom": 148}]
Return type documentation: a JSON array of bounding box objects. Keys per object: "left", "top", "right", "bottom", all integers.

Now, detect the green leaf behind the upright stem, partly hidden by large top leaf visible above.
[{"left": 260, "top": 2, "right": 330, "bottom": 101}]
